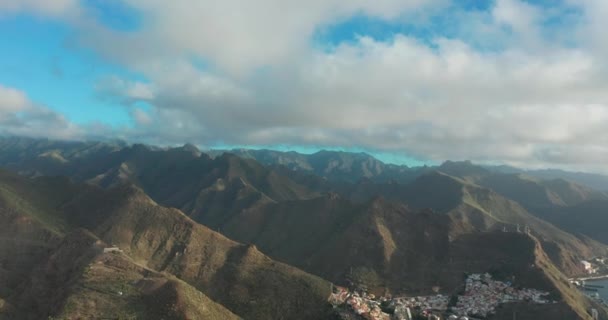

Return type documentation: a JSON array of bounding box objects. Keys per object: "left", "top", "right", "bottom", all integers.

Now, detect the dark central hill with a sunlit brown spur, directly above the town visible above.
[{"left": 205, "top": 194, "right": 448, "bottom": 292}]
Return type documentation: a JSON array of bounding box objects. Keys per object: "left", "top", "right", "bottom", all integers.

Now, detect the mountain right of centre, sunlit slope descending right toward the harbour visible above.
[{"left": 376, "top": 172, "right": 607, "bottom": 275}]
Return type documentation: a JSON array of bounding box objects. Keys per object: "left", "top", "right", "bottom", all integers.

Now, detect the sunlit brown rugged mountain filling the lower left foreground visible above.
[{"left": 0, "top": 172, "right": 330, "bottom": 319}]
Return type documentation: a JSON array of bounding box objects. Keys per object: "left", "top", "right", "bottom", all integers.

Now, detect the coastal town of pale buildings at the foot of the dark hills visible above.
[{"left": 328, "top": 273, "right": 554, "bottom": 320}]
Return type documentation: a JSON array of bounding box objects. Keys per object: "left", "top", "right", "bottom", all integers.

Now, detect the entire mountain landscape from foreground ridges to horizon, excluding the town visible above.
[{"left": 0, "top": 138, "right": 608, "bottom": 319}]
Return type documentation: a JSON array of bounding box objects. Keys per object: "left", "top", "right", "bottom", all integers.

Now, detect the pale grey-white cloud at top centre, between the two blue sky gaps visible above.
[{"left": 76, "top": 0, "right": 444, "bottom": 74}]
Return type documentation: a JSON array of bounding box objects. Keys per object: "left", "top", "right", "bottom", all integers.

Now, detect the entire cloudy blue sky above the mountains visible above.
[{"left": 0, "top": 0, "right": 608, "bottom": 172}]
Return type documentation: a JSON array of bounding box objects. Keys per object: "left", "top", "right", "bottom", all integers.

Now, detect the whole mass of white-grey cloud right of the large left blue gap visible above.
[{"left": 0, "top": 0, "right": 608, "bottom": 169}]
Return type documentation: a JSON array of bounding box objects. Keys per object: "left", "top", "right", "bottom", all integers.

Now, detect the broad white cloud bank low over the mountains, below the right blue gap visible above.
[{"left": 111, "top": 32, "right": 608, "bottom": 169}]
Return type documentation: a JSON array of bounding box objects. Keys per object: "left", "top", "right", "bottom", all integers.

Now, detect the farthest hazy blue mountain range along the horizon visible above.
[{"left": 0, "top": 137, "right": 608, "bottom": 191}]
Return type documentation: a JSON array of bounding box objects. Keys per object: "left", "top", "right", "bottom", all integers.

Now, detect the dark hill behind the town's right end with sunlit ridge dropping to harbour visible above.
[{"left": 449, "top": 232, "right": 608, "bottom": 320}]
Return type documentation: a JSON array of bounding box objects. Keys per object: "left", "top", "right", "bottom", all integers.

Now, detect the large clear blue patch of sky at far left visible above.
[{"left": 0, "top": 15, "right": 130, "bottom": 125}]
